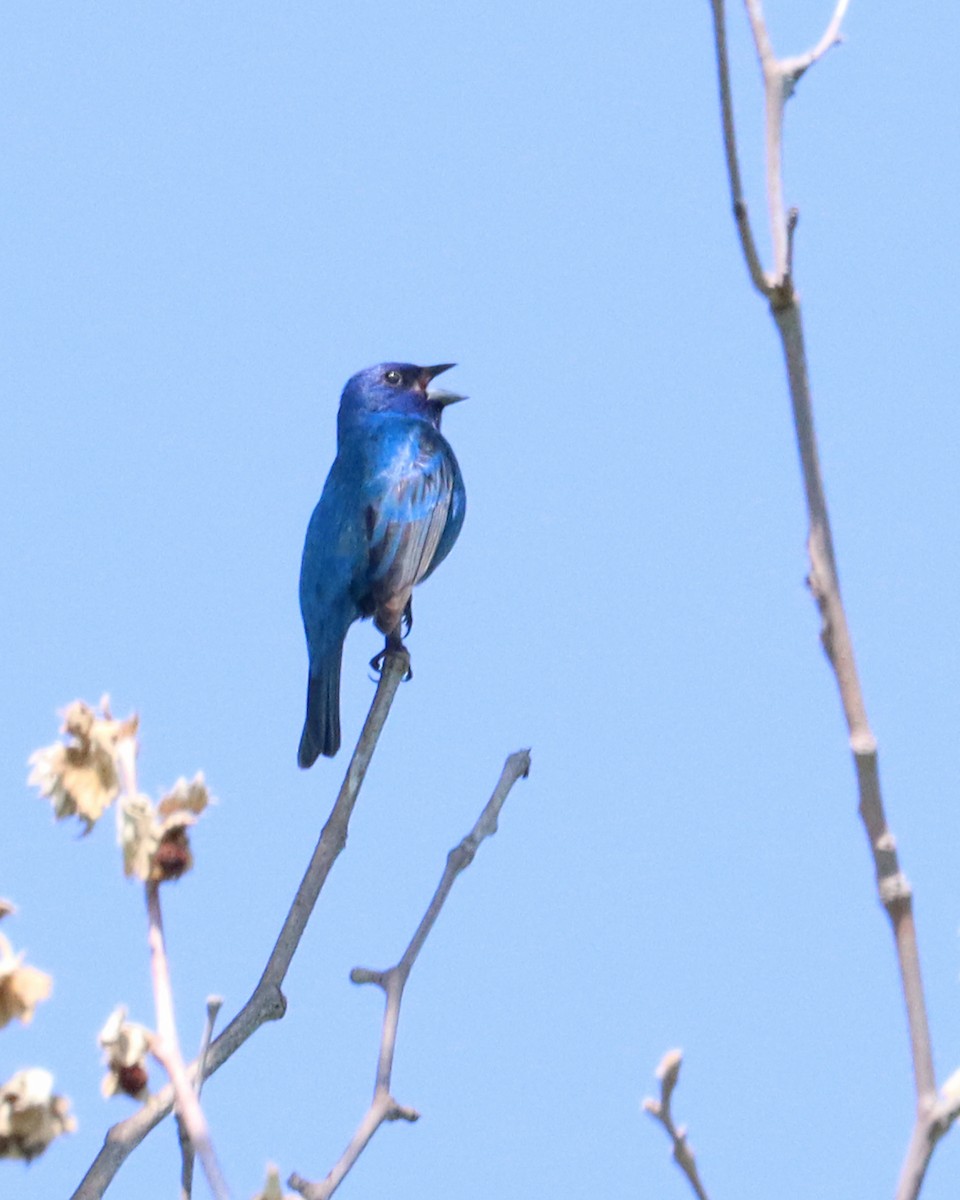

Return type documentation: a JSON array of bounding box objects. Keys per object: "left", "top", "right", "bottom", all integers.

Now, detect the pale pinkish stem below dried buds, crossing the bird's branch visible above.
[{"left": 145, "top": 880, "right": 230, "bottom": 1200}]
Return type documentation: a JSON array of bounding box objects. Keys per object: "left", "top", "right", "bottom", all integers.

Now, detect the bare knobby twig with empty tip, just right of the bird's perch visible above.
[{"left": 287, "top": 750, "right": 530, "bottom": 1200}]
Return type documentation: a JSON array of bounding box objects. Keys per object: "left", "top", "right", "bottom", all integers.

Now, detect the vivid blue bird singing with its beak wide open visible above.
[{"left": 298, "top": 362, "right": 467, "bottom": 767}]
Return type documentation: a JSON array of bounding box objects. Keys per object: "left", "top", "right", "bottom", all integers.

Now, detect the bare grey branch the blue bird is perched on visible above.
[{"left": 71, "top": 649, "right": 409, "bottom": 1200}]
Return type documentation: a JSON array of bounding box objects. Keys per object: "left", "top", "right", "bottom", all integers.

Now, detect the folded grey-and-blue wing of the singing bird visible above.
[{"left": 366, "top": 437, "right": 455, "bottom": 602}]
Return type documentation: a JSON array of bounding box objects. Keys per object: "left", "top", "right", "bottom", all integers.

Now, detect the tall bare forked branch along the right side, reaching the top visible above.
[{"left": 712, "top": 0, "right": 956, "bottom": 1200}]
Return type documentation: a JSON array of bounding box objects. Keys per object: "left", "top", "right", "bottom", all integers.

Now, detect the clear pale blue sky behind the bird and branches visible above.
[{"left": 0, "top": 0, "right": 960, "bottom": 1200}]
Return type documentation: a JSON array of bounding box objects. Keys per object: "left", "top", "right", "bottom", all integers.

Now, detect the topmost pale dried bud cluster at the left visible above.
[{"left": 28, "top": 696, "right": 137, "bottom": 833}]
